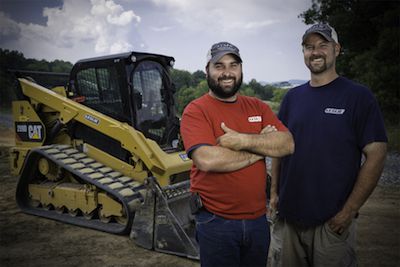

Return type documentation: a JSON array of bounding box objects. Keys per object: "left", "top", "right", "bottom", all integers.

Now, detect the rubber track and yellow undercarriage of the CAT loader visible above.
[{"left": 17, "top": 145, "right": 146, "bottom": 234}]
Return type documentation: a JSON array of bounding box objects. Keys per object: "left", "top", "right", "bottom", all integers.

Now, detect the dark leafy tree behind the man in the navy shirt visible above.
[{"left": 300, "top": 0, "right": 400, "bottom": 125}]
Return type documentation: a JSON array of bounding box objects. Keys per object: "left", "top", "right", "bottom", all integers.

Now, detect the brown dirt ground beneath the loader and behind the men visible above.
[{"left": 0, "top": 128, "right": 400, "bottom": 267}]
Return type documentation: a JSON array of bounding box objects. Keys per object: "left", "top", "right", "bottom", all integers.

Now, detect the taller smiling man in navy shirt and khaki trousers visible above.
[{"left": 271, "top": 24, "right": 387, "bottom": 267}]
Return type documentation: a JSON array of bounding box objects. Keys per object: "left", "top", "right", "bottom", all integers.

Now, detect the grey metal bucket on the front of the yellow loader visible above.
[{"left": 130, "top": 177, "right": 200, "bottom": 259}]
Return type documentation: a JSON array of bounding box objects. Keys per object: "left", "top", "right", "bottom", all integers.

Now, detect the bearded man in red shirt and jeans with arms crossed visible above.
[{"left": 181, "top": 42, "right": 294, "bottom": 267}]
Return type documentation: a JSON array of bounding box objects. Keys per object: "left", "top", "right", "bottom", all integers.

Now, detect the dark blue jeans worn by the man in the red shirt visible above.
[{"left": 196, "top": 210, "right": 270, "bottom": 267}]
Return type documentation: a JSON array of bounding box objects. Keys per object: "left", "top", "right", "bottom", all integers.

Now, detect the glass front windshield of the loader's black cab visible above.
[{"left": 132, "top": 61, "right": 168, "bottom": 145}]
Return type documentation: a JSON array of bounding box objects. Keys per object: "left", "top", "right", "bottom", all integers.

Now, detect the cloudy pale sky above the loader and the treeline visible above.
[{"left": 0, "top": 0, "right": 312, "bottom": 82}]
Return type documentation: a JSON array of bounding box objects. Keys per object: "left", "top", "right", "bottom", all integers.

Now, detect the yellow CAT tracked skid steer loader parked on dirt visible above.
[{"left": 10, "top": 52, "right": 199, "bottom": 259}]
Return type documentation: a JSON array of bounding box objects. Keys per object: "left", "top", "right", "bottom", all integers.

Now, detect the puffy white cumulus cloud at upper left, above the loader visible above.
[{"left": 0, "top": 0, "right": 141, "bottom": 58}]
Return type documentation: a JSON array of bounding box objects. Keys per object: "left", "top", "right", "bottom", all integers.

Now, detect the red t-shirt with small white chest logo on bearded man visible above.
[{"left": 181, "top": 94, "right": 287, "bottom": 219}]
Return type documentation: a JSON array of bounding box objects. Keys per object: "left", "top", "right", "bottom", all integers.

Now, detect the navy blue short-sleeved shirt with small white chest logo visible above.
[{"left": 279, "top": 77, "right": 387, "bottom": 226}]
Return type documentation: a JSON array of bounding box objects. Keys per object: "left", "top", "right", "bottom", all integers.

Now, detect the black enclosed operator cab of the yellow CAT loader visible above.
[{"left": 69, "top": 52, "right": 179, "bottom": 155}]
